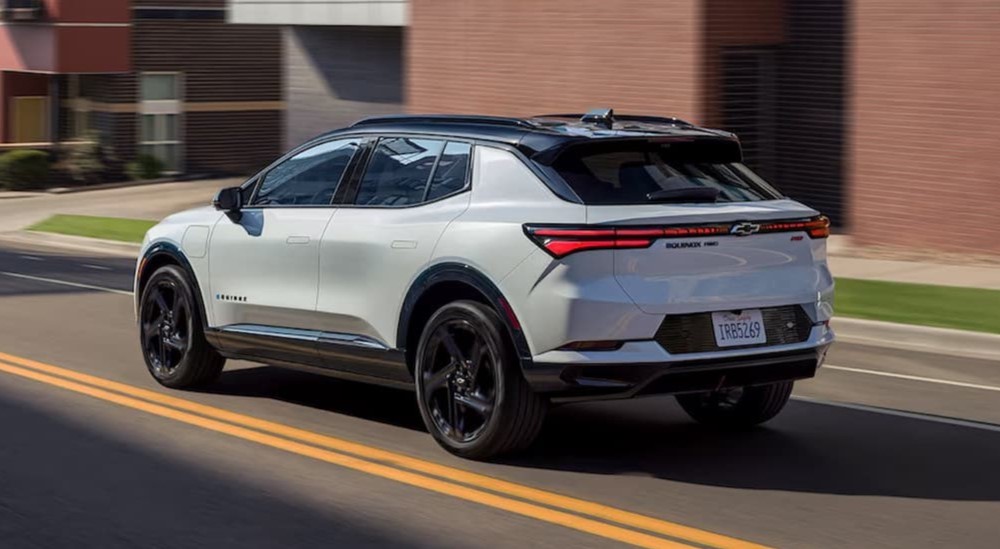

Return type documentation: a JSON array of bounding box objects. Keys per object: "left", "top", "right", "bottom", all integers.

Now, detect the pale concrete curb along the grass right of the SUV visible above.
[{"left": 831, "top": 317, "right": 1000, "bottom": 361}]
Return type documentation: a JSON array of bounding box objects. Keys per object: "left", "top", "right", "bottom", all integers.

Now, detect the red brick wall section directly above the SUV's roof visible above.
[{"left": 404, "top": 0, "right": 703, "bottom": 120}]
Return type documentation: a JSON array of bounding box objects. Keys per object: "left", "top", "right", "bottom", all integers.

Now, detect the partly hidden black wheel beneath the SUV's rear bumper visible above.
[{"left": 677, "top": 381, "right": 794, "bottom": 428}]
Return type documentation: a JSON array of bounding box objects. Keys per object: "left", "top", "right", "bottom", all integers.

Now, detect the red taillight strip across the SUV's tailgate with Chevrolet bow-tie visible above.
[{"left": 524, "top": 216, "right": 830, "bottom": 258}]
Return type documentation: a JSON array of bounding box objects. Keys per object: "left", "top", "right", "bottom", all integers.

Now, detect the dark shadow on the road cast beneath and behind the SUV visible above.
[{"left": 209, "top": 367, "right": 1000, "bottom": 501}]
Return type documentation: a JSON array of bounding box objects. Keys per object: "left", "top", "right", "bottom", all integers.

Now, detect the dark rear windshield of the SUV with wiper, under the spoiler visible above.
[{"left": 546, "top": 141, "right": 782, "bottom": 205}]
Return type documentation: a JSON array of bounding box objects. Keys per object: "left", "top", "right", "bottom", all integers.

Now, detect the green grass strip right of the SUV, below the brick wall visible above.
[{"left": 834, "top": 278, "right": 1000, "bottom": 334}]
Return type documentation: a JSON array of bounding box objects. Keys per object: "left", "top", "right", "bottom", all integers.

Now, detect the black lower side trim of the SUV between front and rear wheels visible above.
[{"left": 207, "top": 325, "right": 413, "bottom": 387}]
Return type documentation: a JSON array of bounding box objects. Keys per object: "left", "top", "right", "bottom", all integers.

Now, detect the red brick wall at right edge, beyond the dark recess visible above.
[{"left": 849, "top": 0, "right": 1000, "bottom": 255}]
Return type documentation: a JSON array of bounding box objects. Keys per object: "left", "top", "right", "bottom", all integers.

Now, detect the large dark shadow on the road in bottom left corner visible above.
[{"left": 0, "top": 395, "right": 419, "bottom": 549}]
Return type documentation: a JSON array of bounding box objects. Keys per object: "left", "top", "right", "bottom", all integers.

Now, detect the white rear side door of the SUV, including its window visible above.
[{"left": 317, "top": 137, "right": 472, "bottom": 377}]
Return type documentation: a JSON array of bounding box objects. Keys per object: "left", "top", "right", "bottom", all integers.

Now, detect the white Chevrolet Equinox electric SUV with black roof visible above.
[{"left": 135, "top": 110, "right": 834, "bottom": 459}]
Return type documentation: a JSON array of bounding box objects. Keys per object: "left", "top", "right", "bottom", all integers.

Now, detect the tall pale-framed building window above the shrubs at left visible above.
[{"left": 139, "top": 73, "right": 182, "bottom": 173}]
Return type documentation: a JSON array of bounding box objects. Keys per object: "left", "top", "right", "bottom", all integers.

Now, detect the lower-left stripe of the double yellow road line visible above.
[{"left": 0, "top": 362, "right": 692, "bottom": 549}]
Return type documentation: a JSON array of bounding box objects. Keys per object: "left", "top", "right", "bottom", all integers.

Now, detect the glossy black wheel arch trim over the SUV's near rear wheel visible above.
[{"left": 396, "top": 263, "right": 531, "bottom": 373}]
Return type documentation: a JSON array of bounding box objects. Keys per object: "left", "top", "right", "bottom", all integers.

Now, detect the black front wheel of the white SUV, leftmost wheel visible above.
[{"left": 139, "top": 265, "right": 226, "bottom": 389}]
